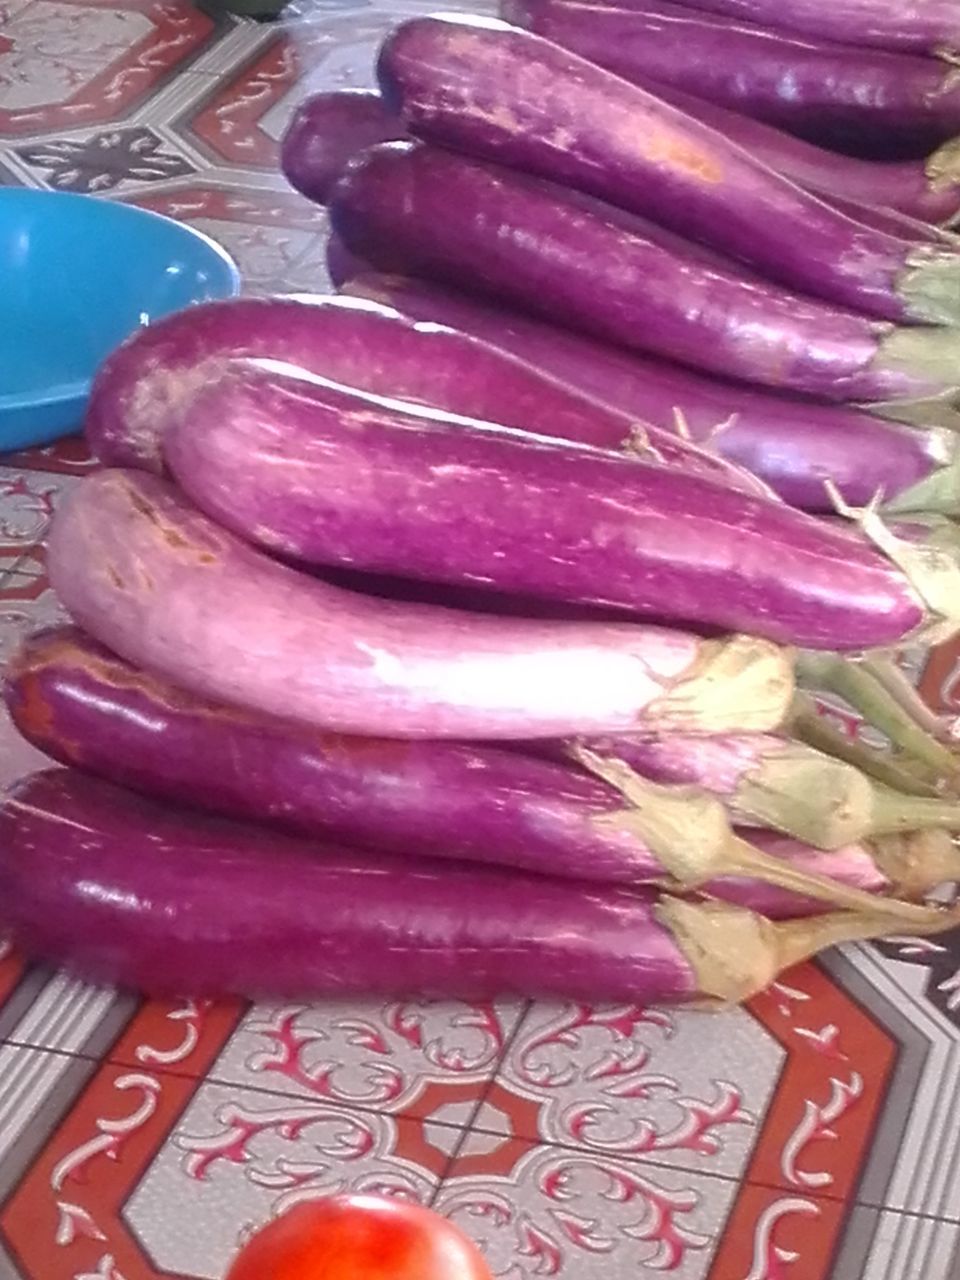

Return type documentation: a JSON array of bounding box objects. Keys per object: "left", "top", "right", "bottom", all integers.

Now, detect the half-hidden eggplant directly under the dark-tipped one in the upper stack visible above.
[{"left": 344, "top": 275, "right": 960, "bottom": 515}]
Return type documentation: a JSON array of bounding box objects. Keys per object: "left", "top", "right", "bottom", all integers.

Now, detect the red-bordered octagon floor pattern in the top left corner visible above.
[{"left": 0, "top": 0, "right": 232, "bottom": 138}]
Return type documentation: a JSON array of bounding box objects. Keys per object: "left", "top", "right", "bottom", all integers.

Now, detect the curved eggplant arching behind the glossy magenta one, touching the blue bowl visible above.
[{"left": 86, "top": 296, "right": 768, "bottom": 494}]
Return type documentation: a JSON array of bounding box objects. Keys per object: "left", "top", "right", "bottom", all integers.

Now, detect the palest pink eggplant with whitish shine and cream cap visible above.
[{"left": 49, "top": 471, "right": 794, "bottom": 739}]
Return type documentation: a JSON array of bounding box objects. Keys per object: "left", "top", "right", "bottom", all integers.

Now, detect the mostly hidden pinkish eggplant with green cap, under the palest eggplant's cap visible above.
[{"left": 579, "top": 733, "right": 960, "bottom": 849}]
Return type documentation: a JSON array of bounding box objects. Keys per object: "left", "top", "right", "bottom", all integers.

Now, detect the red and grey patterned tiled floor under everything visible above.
[{"left": 0, "top": 0, "right": 960, "bottom": 1280}]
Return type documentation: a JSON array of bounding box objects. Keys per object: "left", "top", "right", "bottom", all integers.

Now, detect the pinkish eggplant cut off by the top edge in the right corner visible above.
[{"left": 647, "top": 0, "right": 960, "bottom": 54}]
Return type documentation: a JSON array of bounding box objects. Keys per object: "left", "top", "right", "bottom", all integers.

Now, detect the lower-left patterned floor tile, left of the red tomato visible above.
[{"left": 0, "top": 1046, "right": 458, "bottom": 1280}]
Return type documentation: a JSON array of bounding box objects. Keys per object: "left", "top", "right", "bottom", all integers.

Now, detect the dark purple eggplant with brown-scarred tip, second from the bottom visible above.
[{"left": 4, "top": 628, "right": 926, "bottom": 915}]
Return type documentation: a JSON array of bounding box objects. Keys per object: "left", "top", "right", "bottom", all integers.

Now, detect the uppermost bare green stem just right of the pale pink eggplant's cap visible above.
[{"left": 797, "top": 653, "right": 960, "bottom": 778}]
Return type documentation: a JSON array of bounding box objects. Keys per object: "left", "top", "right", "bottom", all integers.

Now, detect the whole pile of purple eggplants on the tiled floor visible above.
[{"left": 0, "top": 0, "right": 960, "bottom": 1002}]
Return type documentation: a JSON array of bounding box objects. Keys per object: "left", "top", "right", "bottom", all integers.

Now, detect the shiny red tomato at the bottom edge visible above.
[{"left": 227, "top": 1196, "right": 492, "bottom": 1280}]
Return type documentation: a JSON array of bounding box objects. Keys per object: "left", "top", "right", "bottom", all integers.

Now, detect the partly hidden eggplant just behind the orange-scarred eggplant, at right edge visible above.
[{"left": 632, "top": 81, "right": 960, "bottom": 229}]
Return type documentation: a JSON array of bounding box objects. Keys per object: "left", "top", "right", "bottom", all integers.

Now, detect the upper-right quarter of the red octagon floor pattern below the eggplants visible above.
[{"left": 475, "top": 965, "right": 902, "bottom": 1203}]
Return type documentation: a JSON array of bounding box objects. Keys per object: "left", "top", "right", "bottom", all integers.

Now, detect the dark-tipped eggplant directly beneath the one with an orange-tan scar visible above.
[{"left": 330, "top": 142, "right": 960, "bottom": 401}]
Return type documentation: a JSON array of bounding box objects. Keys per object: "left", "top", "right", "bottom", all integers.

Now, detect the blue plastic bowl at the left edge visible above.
[{"left": 0, "top": 187, "right": 239, "bottom": 451}]
